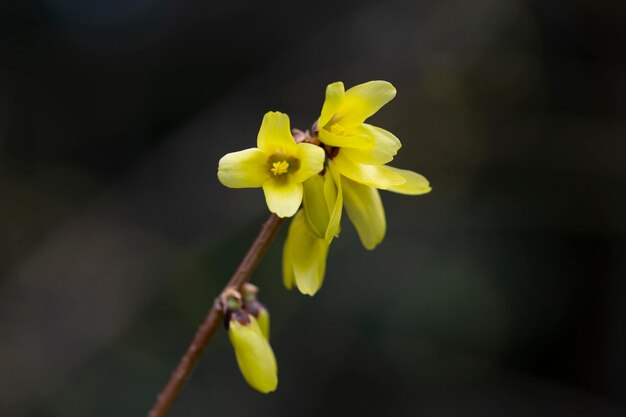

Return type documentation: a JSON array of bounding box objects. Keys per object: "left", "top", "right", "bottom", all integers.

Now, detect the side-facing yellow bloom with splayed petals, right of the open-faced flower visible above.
[{"left": 317, "top": 81, "right": 431, "bottom": 250}]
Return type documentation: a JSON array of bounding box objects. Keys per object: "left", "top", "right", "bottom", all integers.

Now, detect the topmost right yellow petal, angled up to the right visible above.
[{"left": 338, "top": 81, "right": 396, "bottom": 127}]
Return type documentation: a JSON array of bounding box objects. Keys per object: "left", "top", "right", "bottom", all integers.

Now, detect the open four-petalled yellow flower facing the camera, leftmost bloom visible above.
[{"left": 217, "top": 112, "right": 325, "bottom": 217}]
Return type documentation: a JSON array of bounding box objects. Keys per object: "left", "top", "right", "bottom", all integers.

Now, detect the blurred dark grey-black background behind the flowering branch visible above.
[{"left": 0, "top": 0, "right": 626, "bottom": 417}]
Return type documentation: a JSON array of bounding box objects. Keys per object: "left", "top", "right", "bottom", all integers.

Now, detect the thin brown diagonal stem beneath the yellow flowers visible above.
[{"left": 148, "top": 214, "right": 284, "bottom": 417}]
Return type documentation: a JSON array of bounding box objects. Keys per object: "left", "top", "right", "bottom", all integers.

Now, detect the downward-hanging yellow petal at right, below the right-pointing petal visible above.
[{"left": 341, "top": 178, "right": 387, "bottom": 250}]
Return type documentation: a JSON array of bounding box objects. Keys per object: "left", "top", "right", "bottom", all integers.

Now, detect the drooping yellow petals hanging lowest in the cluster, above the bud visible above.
[{"left": 283, "top": 210, "right": 330, "bottom": 296}]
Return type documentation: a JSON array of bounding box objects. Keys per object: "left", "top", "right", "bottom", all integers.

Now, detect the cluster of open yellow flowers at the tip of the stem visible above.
[{"left": 218, "top": 81, "right": 431, "bottom": 391}]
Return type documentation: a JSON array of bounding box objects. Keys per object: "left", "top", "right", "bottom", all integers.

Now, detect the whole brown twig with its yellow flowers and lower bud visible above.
[{"left": 149, "top": 81, "right": 431, "bottom": 417}]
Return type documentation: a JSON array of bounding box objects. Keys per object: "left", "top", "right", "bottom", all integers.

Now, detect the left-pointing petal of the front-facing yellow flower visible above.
[{"left": 217, "top": 148, "right": 268, "bottom": 188}]
